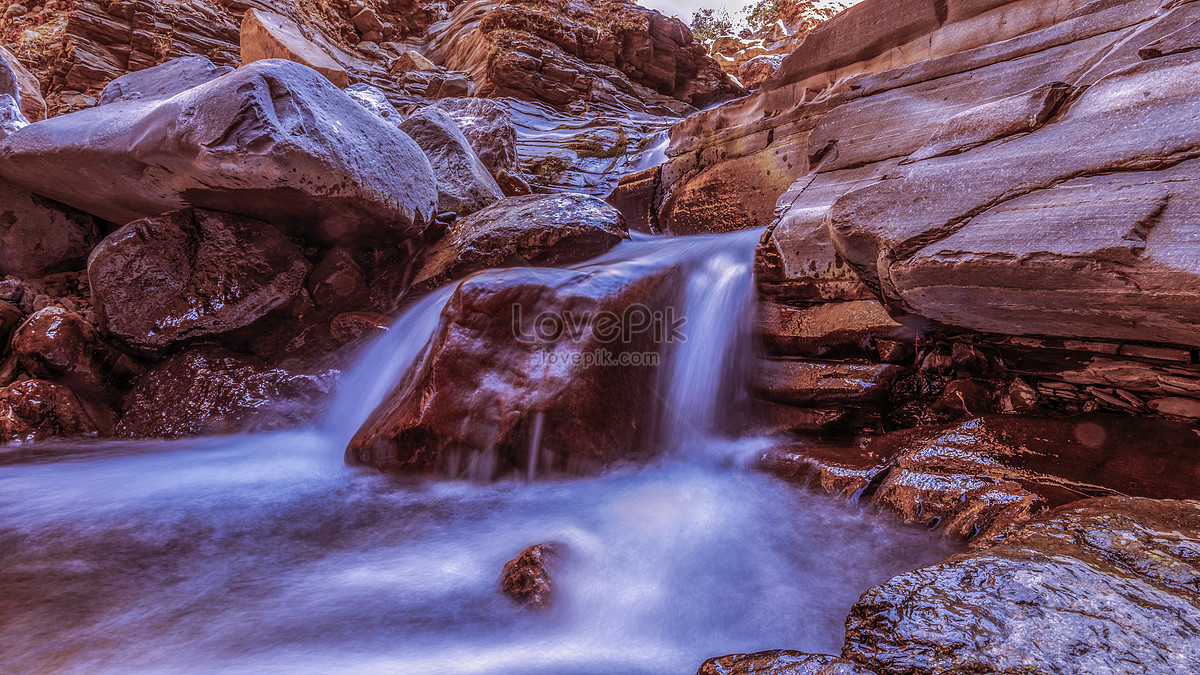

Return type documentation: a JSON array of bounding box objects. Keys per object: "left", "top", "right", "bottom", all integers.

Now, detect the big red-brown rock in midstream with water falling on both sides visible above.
[{"left": 346, "top": 263, "right": 678, "bottom": 478}]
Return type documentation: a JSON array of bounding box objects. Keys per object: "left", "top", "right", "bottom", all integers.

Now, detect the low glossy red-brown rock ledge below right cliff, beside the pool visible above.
[{"left": 766, "top": 414, "right": 1200, "bottom": 546}]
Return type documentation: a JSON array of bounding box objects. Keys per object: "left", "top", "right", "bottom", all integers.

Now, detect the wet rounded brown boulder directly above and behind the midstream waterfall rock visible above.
[{"left": 409, "top": 193, "right": 629, "bottom": 293}]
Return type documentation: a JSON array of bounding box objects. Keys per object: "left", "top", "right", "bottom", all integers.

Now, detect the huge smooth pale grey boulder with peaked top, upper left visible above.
[{"left": 0, "top": 60, "right": 437, "bottom": 243}]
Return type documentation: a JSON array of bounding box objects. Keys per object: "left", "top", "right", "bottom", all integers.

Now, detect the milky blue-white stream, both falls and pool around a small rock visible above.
[{"left": 0, "top": 233, "right": 949, "bottom": 675}]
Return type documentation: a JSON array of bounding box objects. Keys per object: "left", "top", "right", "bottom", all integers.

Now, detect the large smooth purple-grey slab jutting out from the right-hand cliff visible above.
[{"left": 829, "top": 52, "right": 1200, "bottom": 346}]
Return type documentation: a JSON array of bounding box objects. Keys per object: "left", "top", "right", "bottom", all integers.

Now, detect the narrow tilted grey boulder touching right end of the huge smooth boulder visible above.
[{"left": 400, "top": 106, "right": 504, "bottom": 216}]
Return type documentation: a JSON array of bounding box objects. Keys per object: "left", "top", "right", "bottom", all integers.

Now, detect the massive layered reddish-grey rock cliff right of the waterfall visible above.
[{"left": 610, "top": 1, "right": 1200, "bottom": 437}]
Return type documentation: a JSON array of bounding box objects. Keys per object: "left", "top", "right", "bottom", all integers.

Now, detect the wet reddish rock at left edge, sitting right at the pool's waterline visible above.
[{"left": 0, "top": 380, "right": 116, "bottom": 443}]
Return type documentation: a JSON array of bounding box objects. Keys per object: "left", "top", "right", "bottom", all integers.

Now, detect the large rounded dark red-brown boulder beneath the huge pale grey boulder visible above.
[{"left": 88, "top": 209, "right": 311, "bottom": 353}]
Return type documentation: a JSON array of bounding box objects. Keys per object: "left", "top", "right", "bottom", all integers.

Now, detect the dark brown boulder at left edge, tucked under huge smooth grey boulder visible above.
[{"left": 0, "top": 179, "right": 100, "bottom": 279}]
